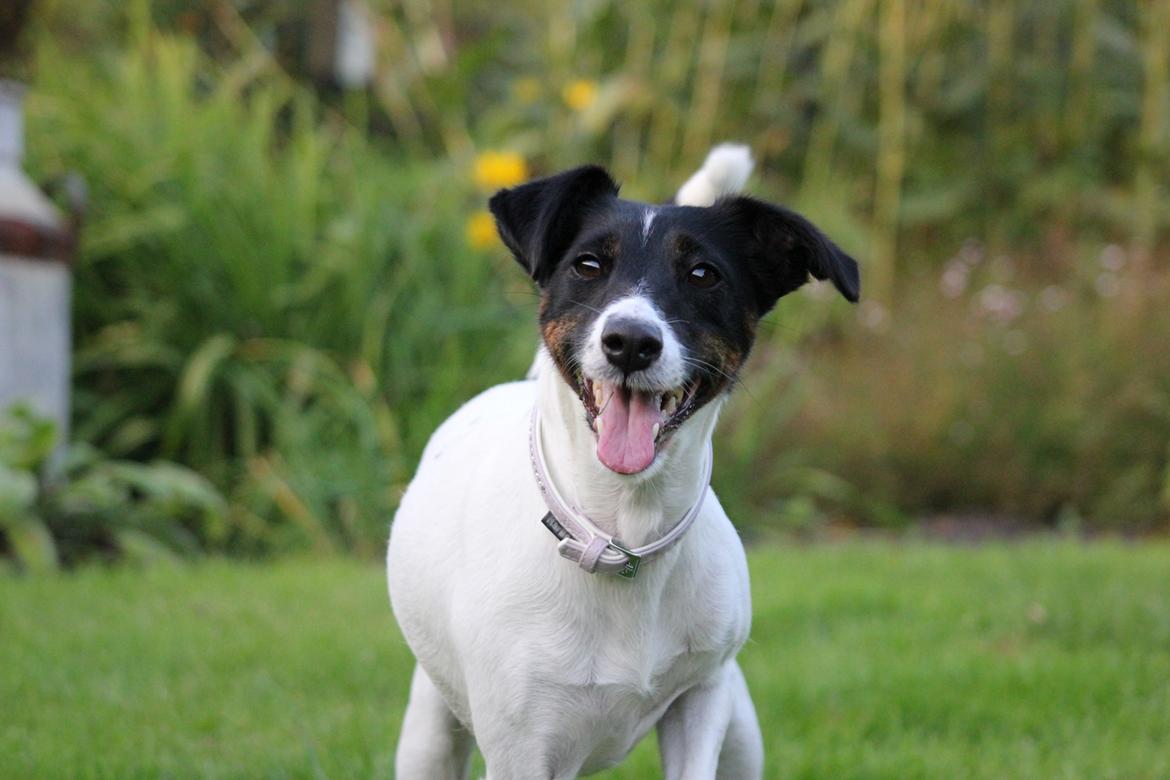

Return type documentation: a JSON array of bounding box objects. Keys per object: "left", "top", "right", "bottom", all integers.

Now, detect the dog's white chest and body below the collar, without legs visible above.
[{"left": 388, "top": 385, "right": 751, "bottom": 771}]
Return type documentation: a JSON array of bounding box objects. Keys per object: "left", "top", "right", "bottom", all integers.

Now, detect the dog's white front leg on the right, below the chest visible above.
[{"left": 658, "top": 661, "right": 764, "bottom": 780}]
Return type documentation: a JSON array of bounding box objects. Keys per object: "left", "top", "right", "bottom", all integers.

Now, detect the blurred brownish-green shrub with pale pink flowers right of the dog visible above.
[{"left": 721, "top": 244, "right": 1170, "bottom": 531}]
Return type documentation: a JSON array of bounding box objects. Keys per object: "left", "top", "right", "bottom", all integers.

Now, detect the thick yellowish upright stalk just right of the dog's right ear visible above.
[{"left": 867, "top": 0, "right": 906, "bottom": 302}]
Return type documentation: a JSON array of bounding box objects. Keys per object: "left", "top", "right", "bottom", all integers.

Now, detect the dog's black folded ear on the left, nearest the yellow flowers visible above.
[{"left": 488, "top": 165, "right": 618, "bottom": 285}]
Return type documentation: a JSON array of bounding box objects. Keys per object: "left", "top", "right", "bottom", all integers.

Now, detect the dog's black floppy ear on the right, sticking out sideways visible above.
[{"left": 714, "top": 196, "right": 861, "bottom": 315}]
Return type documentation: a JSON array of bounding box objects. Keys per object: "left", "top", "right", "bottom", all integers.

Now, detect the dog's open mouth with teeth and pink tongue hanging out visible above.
[{"left": 576, "top": 374, "right": 704, "bottom": 474}]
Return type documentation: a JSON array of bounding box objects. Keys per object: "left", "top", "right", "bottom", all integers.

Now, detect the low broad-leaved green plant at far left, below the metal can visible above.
[{"left": 0, "top": 405, "right": 226, "bottom": 571}]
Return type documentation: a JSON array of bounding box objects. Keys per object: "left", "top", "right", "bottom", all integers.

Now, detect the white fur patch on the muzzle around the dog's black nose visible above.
[{"left": 580, "top": 288, "right": 687, "bottom": 391}]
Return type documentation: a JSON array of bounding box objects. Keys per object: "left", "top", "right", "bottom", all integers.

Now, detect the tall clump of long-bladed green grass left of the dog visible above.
[{"left": 29, "top": 19, "right": 535, "bottom": 552}]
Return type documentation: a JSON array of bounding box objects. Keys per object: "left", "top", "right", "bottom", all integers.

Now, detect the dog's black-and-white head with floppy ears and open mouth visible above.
[{"left": 490, "top": 166, "right": 860, "bottom": 474}]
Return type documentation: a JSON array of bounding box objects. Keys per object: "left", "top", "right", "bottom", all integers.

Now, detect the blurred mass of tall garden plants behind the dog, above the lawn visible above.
[{"left": 13, "top": 0, "right": 1170, "bottom": 563}]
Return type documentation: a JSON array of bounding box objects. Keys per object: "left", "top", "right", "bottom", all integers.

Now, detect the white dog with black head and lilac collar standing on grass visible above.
[{"left": 387, "top": 145, "right": 860, "bottom": 780}]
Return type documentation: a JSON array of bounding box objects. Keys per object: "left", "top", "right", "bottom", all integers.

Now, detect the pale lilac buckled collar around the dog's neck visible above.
[{"left": 528, "top": 405, "right": 715, "bottom": 580}]
